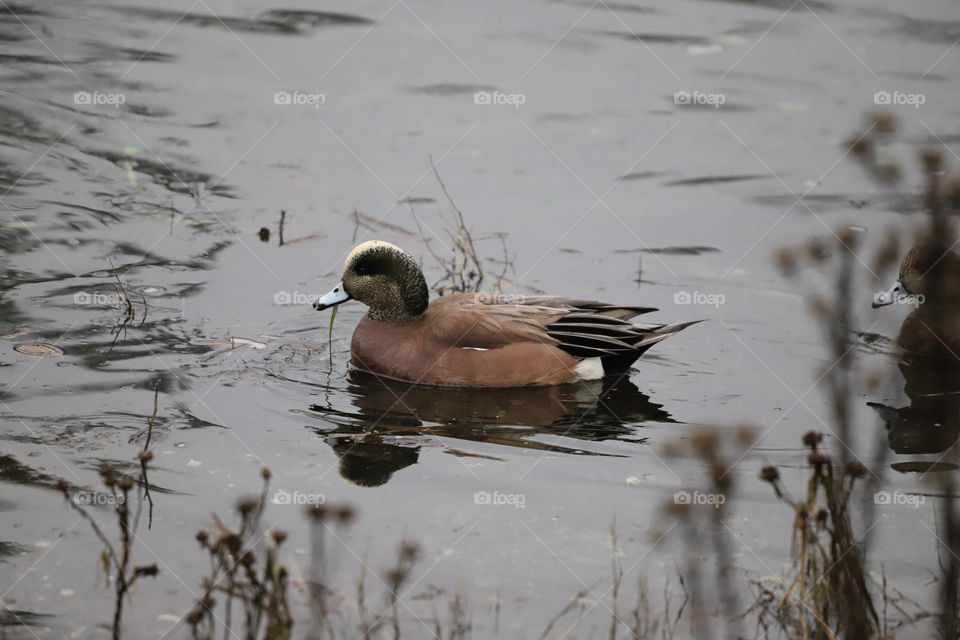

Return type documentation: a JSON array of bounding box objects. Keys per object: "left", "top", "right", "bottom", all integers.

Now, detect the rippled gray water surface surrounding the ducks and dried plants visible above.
[{"left": 0, "top": 0, "right": 960, "bottom": 638}]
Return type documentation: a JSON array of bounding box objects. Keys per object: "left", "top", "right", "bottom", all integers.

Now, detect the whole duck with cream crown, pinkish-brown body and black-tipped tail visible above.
[{"left": 314, "top": 241, "right": 694, "bottom": 387}]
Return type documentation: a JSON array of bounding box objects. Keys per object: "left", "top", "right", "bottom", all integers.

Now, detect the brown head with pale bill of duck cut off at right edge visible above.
[{"left": 873, "top": 243, "right": 960, "bottom": 309}]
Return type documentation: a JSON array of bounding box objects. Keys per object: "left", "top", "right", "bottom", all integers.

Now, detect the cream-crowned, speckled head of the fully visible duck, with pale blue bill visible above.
[{"left": 313, "top": 240, "right": 430, "bottom": 322}]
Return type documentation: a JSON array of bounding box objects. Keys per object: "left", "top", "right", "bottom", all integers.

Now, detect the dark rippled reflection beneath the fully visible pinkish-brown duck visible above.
[{"left": 311, "top": 370, "right": 675, "bottom": 487}]
